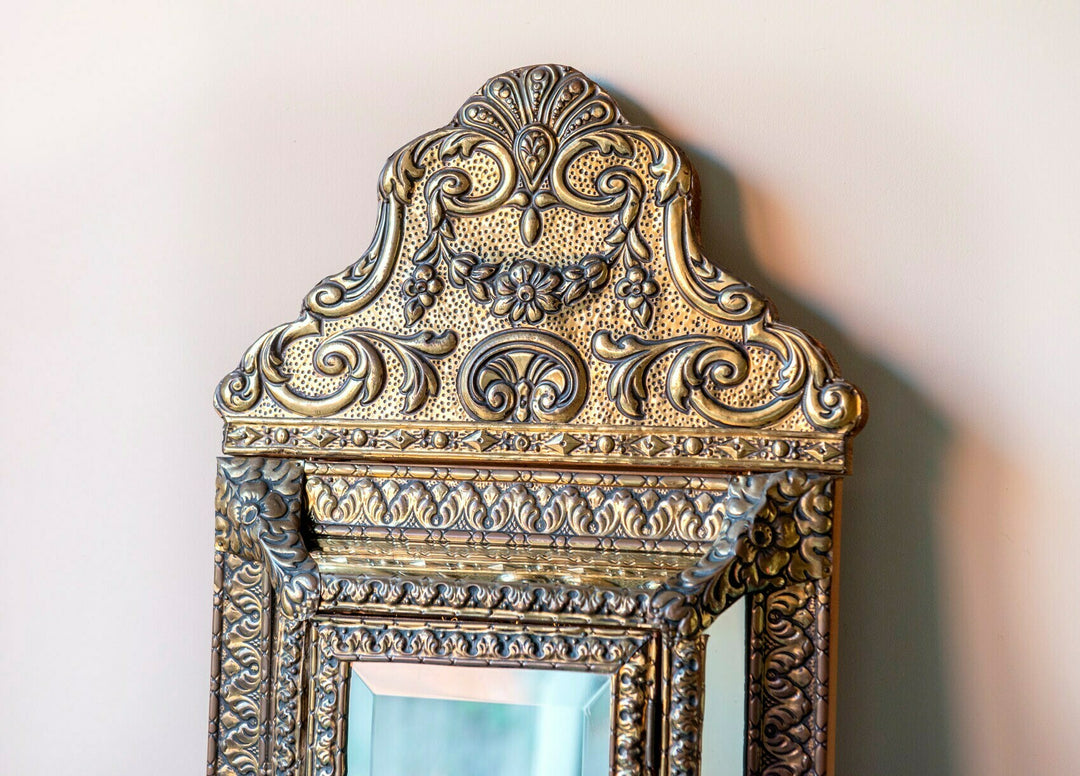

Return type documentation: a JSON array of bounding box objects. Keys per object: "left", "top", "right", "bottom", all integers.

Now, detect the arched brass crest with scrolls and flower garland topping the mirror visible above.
[{"left": 217, "top": 65, "right": 864, "bottom": 472}]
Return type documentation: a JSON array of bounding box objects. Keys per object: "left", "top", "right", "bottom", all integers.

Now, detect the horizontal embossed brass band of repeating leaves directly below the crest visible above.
[{"left": 307, "top": 465, "right": 730, "bottom": 546}]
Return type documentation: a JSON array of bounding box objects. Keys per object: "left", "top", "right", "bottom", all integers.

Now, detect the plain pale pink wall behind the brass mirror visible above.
[{"left": 0, "top": 0, "right": 1080, "bottom": 776}]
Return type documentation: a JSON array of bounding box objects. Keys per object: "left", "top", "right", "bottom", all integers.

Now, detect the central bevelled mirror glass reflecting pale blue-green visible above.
[{"left": 346, "top": 662, "right": 613, "bottom": 776}]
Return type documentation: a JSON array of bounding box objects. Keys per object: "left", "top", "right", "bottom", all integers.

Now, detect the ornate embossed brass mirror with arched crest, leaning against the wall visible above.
[{"left": 208, "top": 65, "right": 865, "bottom": 776}]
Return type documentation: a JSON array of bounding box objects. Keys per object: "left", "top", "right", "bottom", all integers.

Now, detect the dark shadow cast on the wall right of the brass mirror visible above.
[{"left": 606, "top": 86, "right": 957, "bottom": 776}]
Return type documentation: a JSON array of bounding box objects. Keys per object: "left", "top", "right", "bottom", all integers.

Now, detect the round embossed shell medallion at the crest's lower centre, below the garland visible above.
[{"left": 458, "top": 329, "right": 589, "bottom": 423}]
